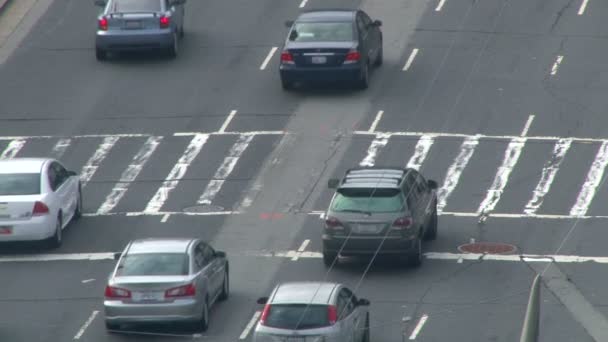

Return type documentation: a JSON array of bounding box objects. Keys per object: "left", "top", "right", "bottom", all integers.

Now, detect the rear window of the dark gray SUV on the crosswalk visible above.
[{"left": 331, "top": 188, "right": 405, "bottom": 213}]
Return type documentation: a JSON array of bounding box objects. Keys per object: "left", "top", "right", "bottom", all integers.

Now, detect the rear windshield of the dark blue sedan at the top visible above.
[{"left": 289, "top": 22, "right": 354, "bottom": 42}]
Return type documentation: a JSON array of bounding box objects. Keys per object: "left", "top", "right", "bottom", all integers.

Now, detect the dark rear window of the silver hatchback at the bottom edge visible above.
[{"left": 266, "top": 304, "right": 329, "bottom": 330}]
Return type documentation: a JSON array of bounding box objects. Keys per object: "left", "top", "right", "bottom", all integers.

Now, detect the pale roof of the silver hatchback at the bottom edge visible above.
[{"left": 269, "top": 281, "right": 339, "bottom": 304}]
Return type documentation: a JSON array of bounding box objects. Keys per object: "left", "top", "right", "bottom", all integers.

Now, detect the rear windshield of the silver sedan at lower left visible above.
[{"left": 117, "top": 253, "right": 189, "bottom": 277}]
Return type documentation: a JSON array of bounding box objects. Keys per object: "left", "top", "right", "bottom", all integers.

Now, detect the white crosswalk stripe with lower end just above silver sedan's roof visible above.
[{"left": 144, "top": 134, "right": 209, "bottom": 213}]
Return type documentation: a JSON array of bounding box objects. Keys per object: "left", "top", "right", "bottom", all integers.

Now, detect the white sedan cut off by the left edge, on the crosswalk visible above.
[{"left": 0, "top": 158, "right": 82, "bottom": 247}]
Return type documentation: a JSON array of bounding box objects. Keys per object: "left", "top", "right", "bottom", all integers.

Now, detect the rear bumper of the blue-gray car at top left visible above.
[{"left": 95, "top": 29, "right": 173, "bottom": 51}]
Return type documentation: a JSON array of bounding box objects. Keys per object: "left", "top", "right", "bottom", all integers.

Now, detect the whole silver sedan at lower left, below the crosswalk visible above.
[{"left": 104, "top": 239, "right": 229, "bottom": 331}]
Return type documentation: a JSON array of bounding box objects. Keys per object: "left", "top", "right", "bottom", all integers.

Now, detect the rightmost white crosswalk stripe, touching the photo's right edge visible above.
[{"left": 570, "top": 142, "right": 608, "bottom": 216}]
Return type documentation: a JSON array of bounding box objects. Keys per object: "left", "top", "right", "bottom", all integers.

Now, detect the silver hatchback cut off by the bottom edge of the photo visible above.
[{"left": 253, "top": 282, "right": 370, "bottom": 342}]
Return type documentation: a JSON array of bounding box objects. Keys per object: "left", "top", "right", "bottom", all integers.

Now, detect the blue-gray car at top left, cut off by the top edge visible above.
[{"left": 95, "top": 0, "right": 186, "bottom": 60}]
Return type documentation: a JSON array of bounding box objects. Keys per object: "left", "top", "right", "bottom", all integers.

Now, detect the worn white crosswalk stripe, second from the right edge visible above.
[{"left": 524, "top": 139, "right": 572, "bottom": 215}]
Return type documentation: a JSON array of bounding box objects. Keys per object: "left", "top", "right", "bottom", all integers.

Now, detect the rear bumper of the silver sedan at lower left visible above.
[{"left": 104, "top": 299, "right": 203, "bottom": 324}]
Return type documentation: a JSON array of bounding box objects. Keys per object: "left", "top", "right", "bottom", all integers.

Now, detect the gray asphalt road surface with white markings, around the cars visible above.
[{"left": 0, "top": 0, "right": 608, "bottom": 342}]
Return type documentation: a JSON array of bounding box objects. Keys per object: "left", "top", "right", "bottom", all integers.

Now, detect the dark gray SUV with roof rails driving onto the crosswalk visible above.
[{"left": 323, "top": 167, "right": 437, "bottom": 266}]
